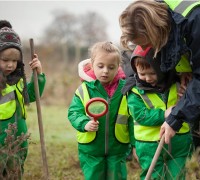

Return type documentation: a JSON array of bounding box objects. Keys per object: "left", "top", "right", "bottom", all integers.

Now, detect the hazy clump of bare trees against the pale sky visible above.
[{"left": 42, "top": 10, "right": 107, "bottom": 62}]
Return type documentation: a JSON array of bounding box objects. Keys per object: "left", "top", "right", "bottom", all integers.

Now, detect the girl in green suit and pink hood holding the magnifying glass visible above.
[{"left": 68, "top": 42, "right": 134, "bottom": 180}]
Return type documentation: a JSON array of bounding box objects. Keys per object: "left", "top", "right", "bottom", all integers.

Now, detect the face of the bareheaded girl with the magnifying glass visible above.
[{"left": 92, "top": 52, "right": 119, "bottom": 85}]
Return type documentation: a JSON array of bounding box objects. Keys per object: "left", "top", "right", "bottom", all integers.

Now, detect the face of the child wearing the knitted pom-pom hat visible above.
[{"left": 0, "top": 48, "right": 20, "bottom": 76}]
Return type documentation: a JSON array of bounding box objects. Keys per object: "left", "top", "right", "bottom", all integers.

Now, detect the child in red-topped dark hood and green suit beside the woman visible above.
[{"left": 128, "top": 46, "right": 192, "bottom": 179}]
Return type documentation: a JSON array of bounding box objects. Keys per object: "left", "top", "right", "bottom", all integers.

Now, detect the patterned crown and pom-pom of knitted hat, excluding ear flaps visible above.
[{"left": 0, "top": 20, "right": 22, "bottom": 52}]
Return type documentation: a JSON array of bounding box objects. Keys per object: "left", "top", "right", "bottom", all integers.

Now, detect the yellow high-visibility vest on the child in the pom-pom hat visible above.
[{"left": 0, "top": 79, "right": 27, "bottom": 120}]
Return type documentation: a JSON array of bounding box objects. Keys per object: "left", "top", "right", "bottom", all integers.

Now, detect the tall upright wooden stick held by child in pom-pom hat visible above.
[{"left": 30, "top": 39, "right": 49, "bottom": 180}]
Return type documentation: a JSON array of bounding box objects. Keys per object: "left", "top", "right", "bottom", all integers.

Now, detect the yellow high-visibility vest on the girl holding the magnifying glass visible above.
[{"left": 75, "top": 82, "right": 130, "bottom": 143}]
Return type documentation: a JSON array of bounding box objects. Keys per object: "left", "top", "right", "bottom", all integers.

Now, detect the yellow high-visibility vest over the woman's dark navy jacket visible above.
[{"left": 164, "top": 0, "right": 200, "bottom": 72}]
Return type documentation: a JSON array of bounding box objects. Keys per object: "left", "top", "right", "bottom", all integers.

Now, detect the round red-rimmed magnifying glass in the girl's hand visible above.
[{"left": 86, "top": 97, "right": 108, "bottom": 121}]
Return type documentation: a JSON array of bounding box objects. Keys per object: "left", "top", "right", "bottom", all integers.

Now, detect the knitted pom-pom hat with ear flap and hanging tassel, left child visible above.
[{"left": 0, "top": 20, "right": 29, "bottom": 104}]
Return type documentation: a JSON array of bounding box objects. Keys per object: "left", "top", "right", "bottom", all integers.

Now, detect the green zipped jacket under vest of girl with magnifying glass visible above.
[{"left": 68, "top": 79, "right": 134, "bottom": 156}]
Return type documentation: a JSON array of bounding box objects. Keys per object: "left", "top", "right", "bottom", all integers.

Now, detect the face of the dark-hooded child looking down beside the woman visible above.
[{"left": 136, "top": 66, "right": 158, "bottom": 86}]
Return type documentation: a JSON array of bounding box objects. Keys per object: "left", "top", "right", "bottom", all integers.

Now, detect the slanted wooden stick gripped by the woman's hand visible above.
[{"left": 145, "top": 134, "right": 165, "bottom": 180}]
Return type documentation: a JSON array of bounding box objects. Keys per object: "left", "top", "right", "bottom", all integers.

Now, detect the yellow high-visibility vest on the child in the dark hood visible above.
[{"left": 132, "top": 84, "right": 189, "bottom": 141}]
